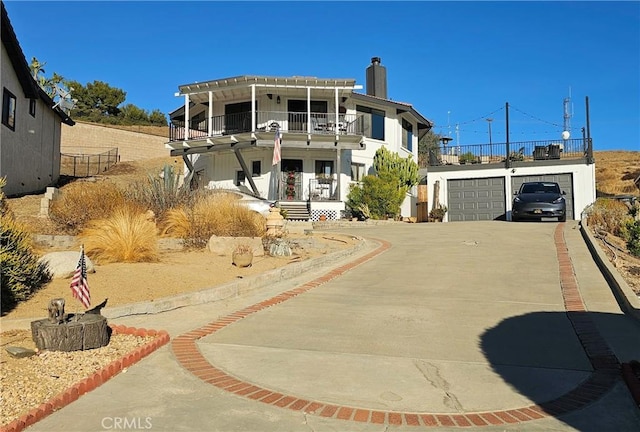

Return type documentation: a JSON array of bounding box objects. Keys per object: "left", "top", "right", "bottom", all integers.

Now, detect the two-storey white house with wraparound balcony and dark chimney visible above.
[{"left": 166, "top": 57, "right": 432, "bottom": 220}]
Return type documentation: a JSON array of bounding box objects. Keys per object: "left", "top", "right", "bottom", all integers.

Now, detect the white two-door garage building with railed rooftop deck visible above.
[{"left": 420, "top": 115, "right": 596, "bottom": 222}]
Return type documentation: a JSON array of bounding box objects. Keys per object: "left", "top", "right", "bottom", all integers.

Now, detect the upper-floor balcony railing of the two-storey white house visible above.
[{"left": 169, "top": 111, "right": 364, "bottom": 141}]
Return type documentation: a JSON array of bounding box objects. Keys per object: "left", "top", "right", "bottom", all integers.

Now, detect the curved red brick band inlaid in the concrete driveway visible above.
[{"left": 172, "top": 228, "right": 620, "bottom": 427}]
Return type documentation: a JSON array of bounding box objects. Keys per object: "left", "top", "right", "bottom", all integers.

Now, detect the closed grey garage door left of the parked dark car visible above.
[{"left": 447, "top": 177, "right": 505, "bottom": 222}]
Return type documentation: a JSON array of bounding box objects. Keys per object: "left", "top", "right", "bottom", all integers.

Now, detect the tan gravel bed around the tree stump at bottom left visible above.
[{"left": 0, "top": 330, "right": 153, "bottom": 425}]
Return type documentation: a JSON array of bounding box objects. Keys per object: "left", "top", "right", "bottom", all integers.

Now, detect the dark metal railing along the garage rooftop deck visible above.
[{"left": 419, "top": 139, "right": 590, "bottom": 168}]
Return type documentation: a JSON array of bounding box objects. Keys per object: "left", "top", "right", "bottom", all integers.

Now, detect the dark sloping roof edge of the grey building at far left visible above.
[{"left": 0, "top": 1, "right": 75, "bottom": 126}]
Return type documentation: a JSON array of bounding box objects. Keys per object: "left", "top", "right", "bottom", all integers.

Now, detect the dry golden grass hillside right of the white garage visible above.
[{"left": 594, "top": 151, "right": 640, "bottom": 196}]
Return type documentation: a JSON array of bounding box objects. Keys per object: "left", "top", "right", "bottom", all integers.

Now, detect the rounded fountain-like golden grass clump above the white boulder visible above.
[{"left": 79, "top": 206, "right": 158, "bottom": 263}]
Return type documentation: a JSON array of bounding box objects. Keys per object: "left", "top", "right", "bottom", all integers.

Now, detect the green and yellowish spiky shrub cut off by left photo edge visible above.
[{"left": 0, "top": 178, "right": 51, "bottom": 313}]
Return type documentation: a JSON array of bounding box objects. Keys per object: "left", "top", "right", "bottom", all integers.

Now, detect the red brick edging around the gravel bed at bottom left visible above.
[{"left": 0, "top": 324, "right": 170, "bottom": 432}]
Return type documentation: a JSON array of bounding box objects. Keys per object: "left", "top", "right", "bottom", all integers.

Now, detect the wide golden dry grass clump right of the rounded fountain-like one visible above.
[{"left": 161, "top": 193, "right": 266, "bottom": 248}]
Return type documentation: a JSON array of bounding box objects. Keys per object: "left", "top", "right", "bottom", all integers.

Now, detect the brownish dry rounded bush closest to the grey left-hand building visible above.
[{"left": 49, "top": 182, "right": 133, "bottom": 235}]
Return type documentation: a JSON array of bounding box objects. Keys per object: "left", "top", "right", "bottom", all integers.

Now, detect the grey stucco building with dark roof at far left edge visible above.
[{"left": 0, "top": 2, "right": 74, "bottom": 196}]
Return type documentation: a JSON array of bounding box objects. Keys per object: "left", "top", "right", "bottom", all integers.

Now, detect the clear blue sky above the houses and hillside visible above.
[{"left": 5, "top": 1, "right": 640, "bottom": 151}]
